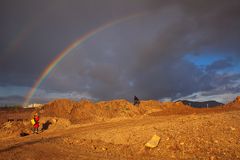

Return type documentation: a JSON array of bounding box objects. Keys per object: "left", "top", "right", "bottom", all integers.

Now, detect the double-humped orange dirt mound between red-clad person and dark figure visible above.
[{"left": 40, "top": 99, "right": 141, "bottom": 123}]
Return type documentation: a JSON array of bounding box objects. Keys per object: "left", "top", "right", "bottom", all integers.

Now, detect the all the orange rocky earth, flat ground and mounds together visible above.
[{"left": 0, "top": 97, "right": 240, "bottom": 160}]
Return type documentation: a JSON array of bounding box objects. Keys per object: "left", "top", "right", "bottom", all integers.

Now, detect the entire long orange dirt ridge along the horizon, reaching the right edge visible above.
[{"left": 40, "top": 96, "right": 240, "bottom": 123}]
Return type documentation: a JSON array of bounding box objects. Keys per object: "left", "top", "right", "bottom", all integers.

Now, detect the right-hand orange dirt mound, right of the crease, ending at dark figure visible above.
[{"left": 70, "top": 100, "right": 140, "bottom": 123}]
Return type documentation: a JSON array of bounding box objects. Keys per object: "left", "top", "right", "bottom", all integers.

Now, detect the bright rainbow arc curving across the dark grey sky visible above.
[{"left": 23, "top": 13, "right": 146, "bottom": 106}]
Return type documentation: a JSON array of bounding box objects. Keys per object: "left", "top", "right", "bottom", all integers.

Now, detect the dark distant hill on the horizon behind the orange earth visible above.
[{"left": 177, "top": 100, "right": 224, "bottom": 108}]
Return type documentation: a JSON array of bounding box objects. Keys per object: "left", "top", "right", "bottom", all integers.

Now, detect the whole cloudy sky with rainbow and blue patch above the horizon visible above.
[{"left": 0, "top": 0, "right": 240, "bottom": 104}]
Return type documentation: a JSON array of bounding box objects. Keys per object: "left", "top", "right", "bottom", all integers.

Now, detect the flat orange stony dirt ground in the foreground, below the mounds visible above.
[{"left": 0, "top": 109, "right": 240, "bottom": 160}]
